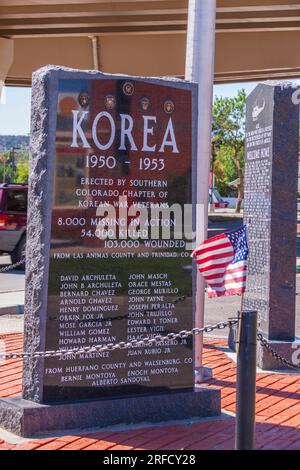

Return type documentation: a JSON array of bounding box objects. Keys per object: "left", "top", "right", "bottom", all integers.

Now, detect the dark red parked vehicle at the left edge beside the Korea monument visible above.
[{"left": 0, "top": 184, "right": 28, "bottom": 269}]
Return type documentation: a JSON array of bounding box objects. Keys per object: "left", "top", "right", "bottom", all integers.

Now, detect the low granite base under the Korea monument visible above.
[{"left": 0, "top": 386, "right": 221, "bottom": 437}]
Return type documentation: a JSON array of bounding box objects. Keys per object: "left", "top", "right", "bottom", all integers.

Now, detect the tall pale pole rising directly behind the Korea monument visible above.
[{"left": 185, "top": 0, "right": 216, "bottom": 382}]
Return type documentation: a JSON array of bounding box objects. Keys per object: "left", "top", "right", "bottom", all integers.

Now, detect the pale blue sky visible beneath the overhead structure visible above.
[{"left": 0, "top": 80, "right": 299, "bottom": 135}]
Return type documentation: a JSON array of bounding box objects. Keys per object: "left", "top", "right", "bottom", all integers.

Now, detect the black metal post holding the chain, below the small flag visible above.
[{"left": 235, "top": 311, "right": 257, "bottom": 450}]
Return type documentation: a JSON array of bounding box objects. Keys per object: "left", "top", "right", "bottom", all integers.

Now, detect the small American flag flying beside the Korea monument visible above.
[{"left": 192, "top": 225, "right": 248, "bottom": 297}]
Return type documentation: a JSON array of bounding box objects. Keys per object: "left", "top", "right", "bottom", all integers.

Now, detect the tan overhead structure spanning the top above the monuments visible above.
[{"left": 0, "top": 0, "right": 300, "bottom": 85}]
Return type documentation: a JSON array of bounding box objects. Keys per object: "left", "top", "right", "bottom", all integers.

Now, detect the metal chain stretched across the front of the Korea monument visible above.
[{"left": 0, "top": 318, "right": 239, "bottom": 360}]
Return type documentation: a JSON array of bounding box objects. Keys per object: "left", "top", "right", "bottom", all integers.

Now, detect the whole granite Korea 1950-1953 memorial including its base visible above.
[{"left": 0, "top": 66, "right": 220, "bottom": 436}]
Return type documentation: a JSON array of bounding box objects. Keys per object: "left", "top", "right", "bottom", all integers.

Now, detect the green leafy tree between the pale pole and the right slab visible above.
[{"left": 212, "top": 90, "right": 246, "bottom": 212}]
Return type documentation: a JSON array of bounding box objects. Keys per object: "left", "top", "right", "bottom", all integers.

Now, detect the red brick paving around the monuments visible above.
[{"left": 0, "top": 334, "right": 300, "bottom": 450}]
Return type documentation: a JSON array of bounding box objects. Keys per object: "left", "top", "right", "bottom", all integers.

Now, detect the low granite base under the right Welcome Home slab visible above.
[{"left": 257, "top": 340, "right": 300, "bottom": 370}]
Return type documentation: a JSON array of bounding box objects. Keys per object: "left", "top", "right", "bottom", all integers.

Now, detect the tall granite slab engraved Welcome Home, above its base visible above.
[{"left": 243, "top": 82, "right": 299, "bottom": 341}]
